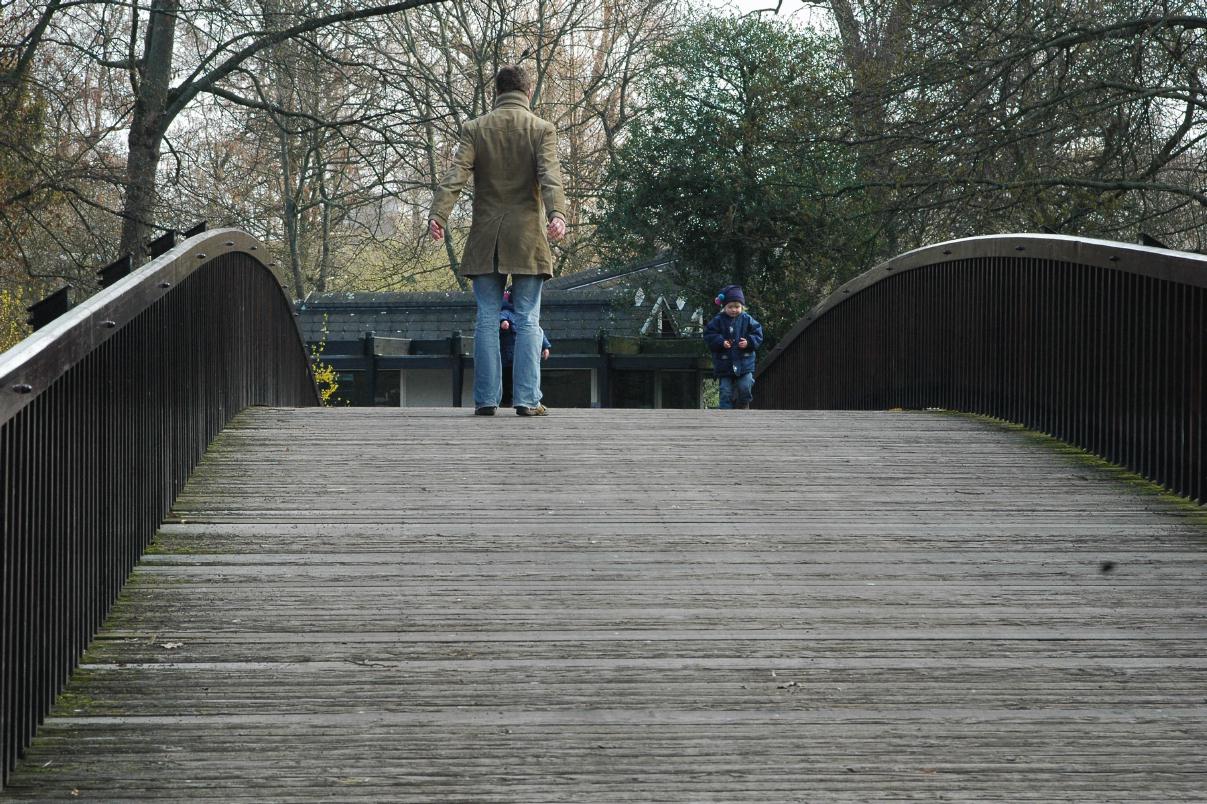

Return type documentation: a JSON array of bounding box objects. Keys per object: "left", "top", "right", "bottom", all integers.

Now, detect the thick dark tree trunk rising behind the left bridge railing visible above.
[{"left": 121, "top": 0, "right": 180, "bottom": 259}]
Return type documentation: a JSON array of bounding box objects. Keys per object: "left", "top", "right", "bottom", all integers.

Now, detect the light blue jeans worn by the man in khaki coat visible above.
[{"left": 471, "top": 274, "right": 544, "bottom": 408}]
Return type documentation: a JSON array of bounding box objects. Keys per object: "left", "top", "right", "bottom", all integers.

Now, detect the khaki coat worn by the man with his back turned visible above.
[{"left": 430, "top": 92, "right": 566, "bottom": 279}]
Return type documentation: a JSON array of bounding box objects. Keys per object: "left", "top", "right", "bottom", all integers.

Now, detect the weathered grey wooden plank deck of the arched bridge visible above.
[{"left": 5, "top": 409, "right": 1207, "bottom": 802}]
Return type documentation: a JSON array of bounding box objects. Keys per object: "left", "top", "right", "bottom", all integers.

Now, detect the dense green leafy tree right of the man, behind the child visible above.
[{"left": 597, "top": 17, "right": 875, "bottom": 339}]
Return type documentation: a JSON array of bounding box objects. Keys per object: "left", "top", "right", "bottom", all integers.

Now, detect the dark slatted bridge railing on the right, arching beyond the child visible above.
[{"left": 756, "top": 234, "right": 1207, "bottom": 503}]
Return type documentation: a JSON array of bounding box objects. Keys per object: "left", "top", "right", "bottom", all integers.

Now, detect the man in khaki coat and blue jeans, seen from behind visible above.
[{"left": 428, "top": 65, "right": 566, "bottom": 416}]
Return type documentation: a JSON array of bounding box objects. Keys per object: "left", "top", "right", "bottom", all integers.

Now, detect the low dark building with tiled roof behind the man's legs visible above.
[{"left": 298, "top": 261, "right": 707, "bottom": 407}]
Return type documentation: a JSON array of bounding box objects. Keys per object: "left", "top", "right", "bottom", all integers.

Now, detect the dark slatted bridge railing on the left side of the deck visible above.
[{"left": 0, "top": 229, "right": 317, "bottom": 788}]
